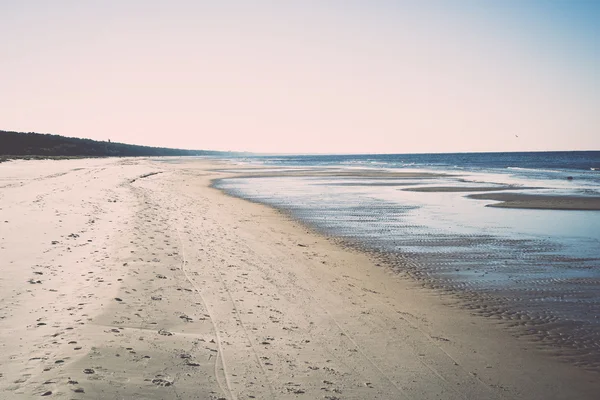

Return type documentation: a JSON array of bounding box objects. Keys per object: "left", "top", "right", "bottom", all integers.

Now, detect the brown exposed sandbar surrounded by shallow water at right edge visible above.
[{"left": 467, "top": 193, "right": 600, "bottom": 211}]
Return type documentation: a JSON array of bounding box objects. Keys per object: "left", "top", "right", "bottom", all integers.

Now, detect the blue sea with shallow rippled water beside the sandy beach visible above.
[{"left": 214, "top": 151, "right": 600, "bottom": 371}]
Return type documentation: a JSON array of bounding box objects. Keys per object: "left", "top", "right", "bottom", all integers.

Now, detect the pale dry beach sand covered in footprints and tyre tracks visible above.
[{"left": 0, "top": 159, "right": 600, "bottom": 400}]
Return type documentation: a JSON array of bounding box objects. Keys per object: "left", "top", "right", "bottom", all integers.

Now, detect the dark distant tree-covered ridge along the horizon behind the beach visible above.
[{"left": 0, "top": 131, "right": 225, "bottom": 157}]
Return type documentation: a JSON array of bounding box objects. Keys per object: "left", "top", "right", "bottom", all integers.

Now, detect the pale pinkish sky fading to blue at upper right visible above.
[{"left": 0, "top": 0, "right": 600, "bottom": 153}]
